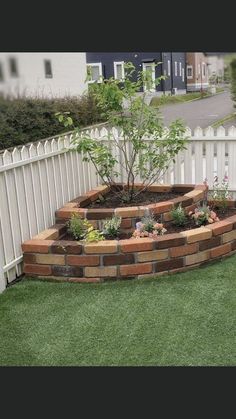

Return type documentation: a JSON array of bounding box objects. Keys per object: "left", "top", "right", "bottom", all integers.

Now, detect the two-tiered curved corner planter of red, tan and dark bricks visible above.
[{"left": 22, "top": 185, "right": 236, "bottom": 282}]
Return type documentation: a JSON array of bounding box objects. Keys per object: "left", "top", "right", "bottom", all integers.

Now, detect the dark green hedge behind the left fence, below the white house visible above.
[{"left": 0, "top": 94, "right": 103, "bottom": 150}]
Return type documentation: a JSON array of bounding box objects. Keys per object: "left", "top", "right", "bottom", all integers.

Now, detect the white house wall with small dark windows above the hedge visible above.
[{"left": 0, "top": 52, "right": 87, "bottom": 98}]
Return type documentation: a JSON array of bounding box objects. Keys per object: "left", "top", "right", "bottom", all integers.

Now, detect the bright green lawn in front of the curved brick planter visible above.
[{"left": 0, "top": 256, "right": 236, "bottom": 366}]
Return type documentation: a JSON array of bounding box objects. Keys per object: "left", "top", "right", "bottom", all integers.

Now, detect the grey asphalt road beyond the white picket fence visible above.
[{"left": 160, "top": 91, "right": 235, "bottom": 129}]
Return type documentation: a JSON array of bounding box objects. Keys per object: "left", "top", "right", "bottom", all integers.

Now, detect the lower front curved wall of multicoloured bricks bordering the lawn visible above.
[{"left": 22, "top": 202, "right": 236, "bottom": 282}]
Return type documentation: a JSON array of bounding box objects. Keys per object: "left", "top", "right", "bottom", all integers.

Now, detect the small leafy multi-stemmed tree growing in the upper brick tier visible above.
[{"left": 58, "top": 63, "right": 186, "bottom": 202}]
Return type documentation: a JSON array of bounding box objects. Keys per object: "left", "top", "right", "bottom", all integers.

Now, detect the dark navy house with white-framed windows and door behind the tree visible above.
[{"left": 86, "top": 52, "right": 186, "bottom": 95}]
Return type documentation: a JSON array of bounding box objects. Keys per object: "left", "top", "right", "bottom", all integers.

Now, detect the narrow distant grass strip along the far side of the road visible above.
[{"left": 150, "top": 87, "right": 224, "bottom": 107}]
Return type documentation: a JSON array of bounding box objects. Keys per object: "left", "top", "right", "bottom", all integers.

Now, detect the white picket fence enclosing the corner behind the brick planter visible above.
[{"left": 0, "top": 127, "right": 236, "bottom": 292}]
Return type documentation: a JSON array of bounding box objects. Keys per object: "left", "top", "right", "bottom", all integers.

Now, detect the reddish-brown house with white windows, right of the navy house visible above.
[{"left": 186, "top": 52, "right": 209, "bottom": 92}]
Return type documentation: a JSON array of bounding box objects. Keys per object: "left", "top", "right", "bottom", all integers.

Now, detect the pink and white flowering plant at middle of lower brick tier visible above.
[{"left": 133, "top": 215, "right": 167, "bottom": 238}]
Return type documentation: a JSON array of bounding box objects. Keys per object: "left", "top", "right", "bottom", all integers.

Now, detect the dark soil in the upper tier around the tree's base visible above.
[{"left": 86, "top": 191, "right": 184, "bottom": 208}]
